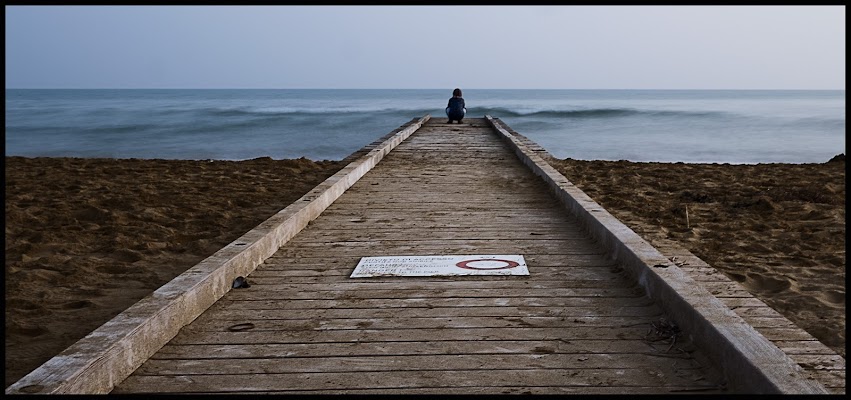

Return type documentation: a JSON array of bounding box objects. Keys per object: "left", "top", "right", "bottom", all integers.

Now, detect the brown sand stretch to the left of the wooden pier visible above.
[{"left": 5, "top": 157, "right": 343, "bottom": 387}]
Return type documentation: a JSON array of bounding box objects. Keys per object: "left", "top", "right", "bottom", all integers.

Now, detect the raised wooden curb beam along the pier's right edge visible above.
[{"left": 485, "top": 115, "right": 828, "bottom": 394}]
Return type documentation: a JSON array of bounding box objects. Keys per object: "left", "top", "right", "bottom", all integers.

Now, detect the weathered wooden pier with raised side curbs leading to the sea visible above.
[{"left": 7, "top": 116, "right": 844, "bottom": 394}]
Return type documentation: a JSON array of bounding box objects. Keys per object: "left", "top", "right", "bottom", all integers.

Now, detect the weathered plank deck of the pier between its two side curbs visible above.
[{"left": 115, "top": 119, "right": 723, "bottom": 394}]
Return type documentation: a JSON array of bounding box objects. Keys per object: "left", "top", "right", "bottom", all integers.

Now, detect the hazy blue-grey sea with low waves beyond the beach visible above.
[{"left": 5, "top": 88, "right": 845, "bottom": 164}]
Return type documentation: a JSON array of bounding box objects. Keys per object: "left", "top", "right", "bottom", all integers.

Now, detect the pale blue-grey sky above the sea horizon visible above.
[{"left": 6, "top": 6, "right": 845, "bottom": 89}]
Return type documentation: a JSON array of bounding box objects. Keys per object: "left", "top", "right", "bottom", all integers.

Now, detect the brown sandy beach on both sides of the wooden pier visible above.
[{"left": 5, "top": 157, "right": 845, "bottom": 386}]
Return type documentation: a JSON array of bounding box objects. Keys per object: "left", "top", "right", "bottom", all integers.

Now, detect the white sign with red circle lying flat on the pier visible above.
[{"left": 350, "top": 254, "right": 529, "bottom": 278}]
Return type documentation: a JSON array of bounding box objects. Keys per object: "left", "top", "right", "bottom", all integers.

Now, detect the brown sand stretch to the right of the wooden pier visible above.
[{"left": 552, "top": 155, "right": 845, "bottom": 357}]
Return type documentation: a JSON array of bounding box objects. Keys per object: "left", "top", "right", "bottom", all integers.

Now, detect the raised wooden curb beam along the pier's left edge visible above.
[{"left": 6, "top": 114, "right": 431, "bottom": 394}]
